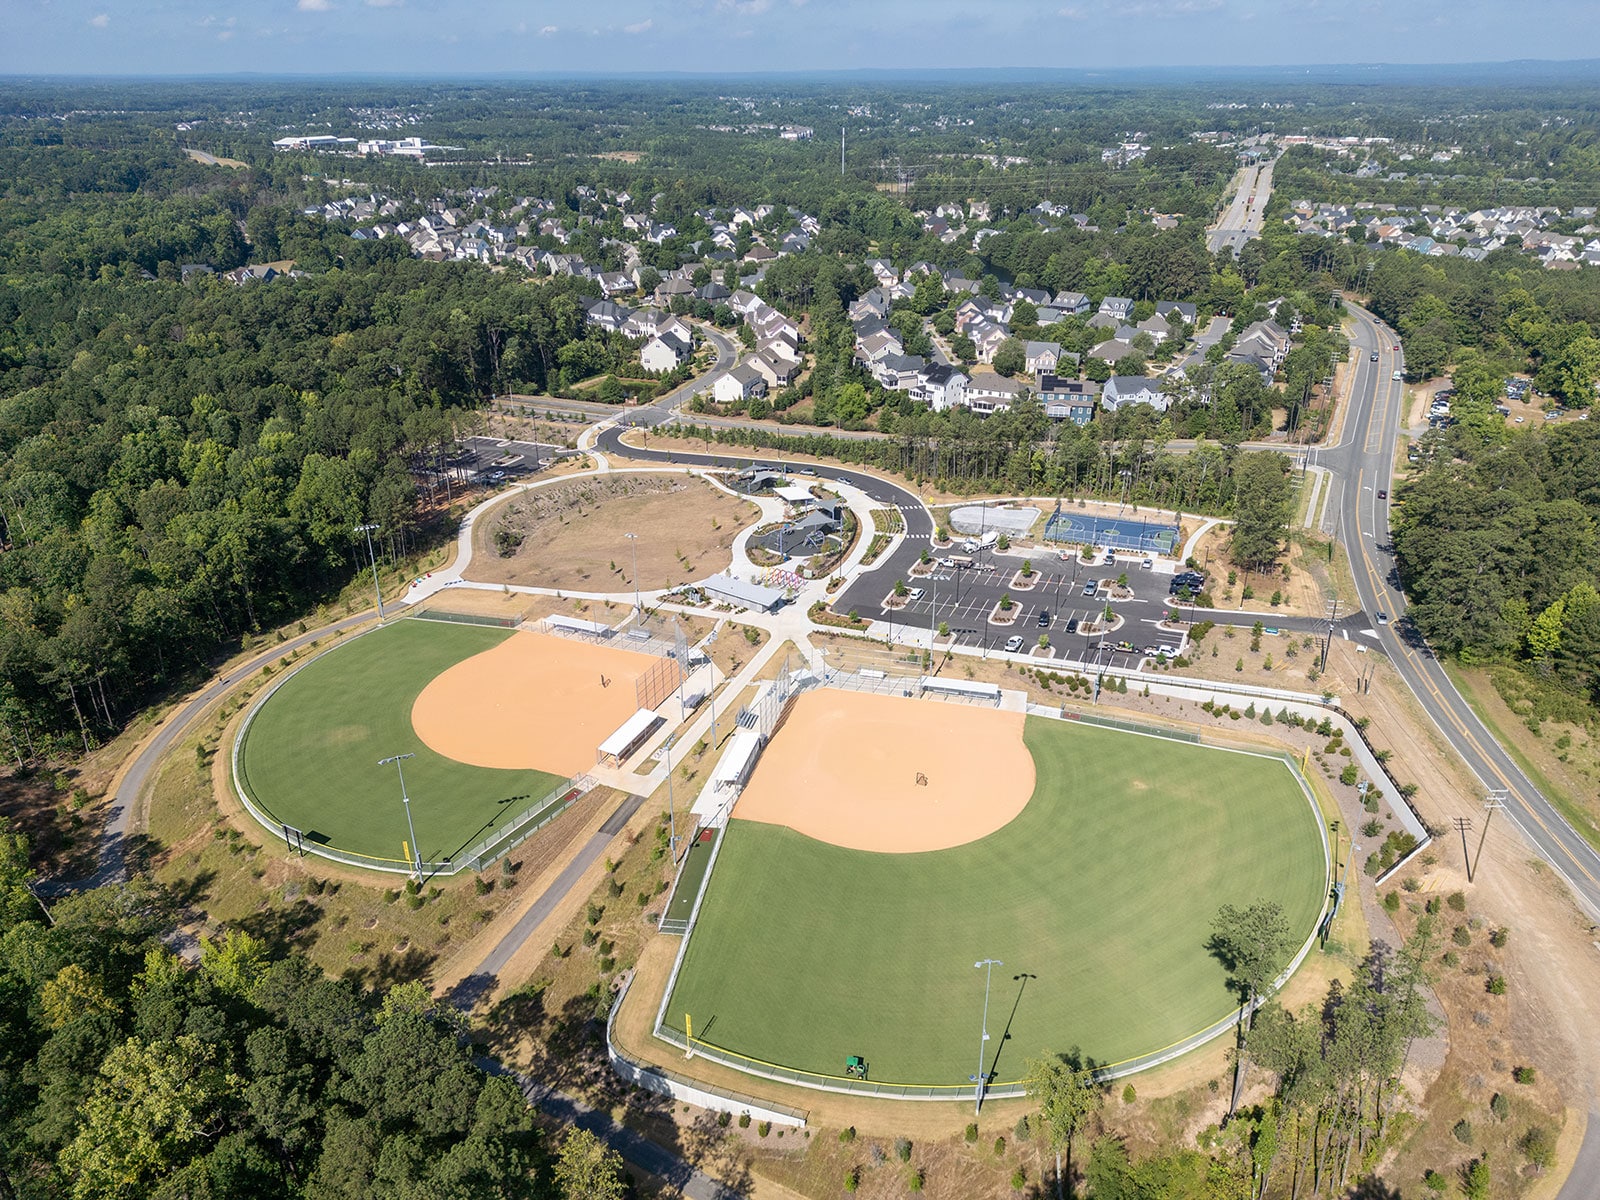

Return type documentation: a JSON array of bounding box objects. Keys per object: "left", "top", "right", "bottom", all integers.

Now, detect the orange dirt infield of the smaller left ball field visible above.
[{"left": 411, "top": 630, "right": 661, "bottom": 774}]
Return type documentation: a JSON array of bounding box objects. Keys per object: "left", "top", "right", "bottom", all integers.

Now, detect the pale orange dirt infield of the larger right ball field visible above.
[{"left": 733, "top": 688, "right": 1034, "bottom": 854}]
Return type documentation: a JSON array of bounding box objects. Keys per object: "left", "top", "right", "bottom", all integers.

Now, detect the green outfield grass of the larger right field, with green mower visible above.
[{"left": 667, "top": 717, "right": 1326, "bottom": 1085}]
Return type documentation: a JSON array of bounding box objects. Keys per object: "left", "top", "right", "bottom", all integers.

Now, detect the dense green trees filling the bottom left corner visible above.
[{"left": 0, "top": 819, "right": 624, "bottom": 1200}]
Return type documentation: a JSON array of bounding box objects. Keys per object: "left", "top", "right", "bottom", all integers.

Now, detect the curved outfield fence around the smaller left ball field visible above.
[{"left": 232, "top": 626, "right": 597, "bottom": 875}]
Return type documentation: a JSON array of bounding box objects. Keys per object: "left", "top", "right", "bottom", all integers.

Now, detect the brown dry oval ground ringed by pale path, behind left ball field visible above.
[{"left": 469, "top": 472, "right": 757, "bottom": 592}]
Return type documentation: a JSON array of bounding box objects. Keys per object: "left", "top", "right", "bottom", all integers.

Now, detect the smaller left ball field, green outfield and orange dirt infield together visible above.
[{"left": 240, "top": 621, "right": 654, "bottom": 862}]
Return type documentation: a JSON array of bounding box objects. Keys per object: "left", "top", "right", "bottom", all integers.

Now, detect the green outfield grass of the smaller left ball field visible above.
[{"left": 233, "top": 621, "right": 562, "bottom": 861}]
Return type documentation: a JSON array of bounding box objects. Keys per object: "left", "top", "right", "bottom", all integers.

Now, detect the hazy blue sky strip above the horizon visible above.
[{"left": 9, "top": 0, "right": 1600, "bottom": 75}]
